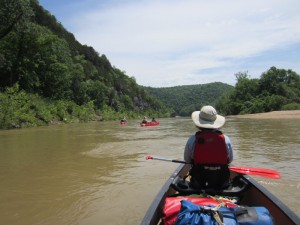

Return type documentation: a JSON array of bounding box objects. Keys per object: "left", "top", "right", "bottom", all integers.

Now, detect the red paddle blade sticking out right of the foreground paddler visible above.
[{"left": 229, "top": 166, "right": 281, "bottom": 179}]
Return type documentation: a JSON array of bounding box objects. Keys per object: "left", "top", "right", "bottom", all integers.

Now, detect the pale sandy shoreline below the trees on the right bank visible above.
[{"left": 226, "top": 110, "right": 300, "bottom": 119}]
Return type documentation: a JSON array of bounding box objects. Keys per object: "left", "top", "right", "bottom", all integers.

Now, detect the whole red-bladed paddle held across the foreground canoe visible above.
[{"left": 146, "top": 155, "right": 281, "bottom": 179}]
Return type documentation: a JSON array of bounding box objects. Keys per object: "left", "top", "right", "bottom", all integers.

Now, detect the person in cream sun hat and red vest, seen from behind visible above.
[{"left": 184, "top": 105, "right": 233, "bottom": 189}]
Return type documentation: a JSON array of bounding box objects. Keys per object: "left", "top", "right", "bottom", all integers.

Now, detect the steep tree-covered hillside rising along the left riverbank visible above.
[{"left": 0, "top": 0, "right": 169, "bottom": 128}]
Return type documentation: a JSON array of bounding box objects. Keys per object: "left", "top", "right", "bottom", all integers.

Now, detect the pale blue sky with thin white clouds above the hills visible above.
[{"left": 39, "top": 0, "right": 300, "bottom": 87}]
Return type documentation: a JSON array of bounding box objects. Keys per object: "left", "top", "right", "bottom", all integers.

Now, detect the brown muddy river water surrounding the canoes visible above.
[{"left": 0, "top": 118, "right": 300, "bottom": 225}]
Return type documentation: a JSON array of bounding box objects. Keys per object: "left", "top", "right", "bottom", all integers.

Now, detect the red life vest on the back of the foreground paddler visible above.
[{"left": 194, "top": 131, "right": 228, "bottom": 165}]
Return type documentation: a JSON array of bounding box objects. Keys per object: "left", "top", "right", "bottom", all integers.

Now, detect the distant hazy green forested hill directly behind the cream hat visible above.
[{"left": 145, "top": 82, "right": 233, "bottom": 116}]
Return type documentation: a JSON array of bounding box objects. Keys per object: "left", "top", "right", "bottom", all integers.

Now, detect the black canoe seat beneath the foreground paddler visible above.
[{"left": 171, "top": 176, "right": 248, "bottom": 196}]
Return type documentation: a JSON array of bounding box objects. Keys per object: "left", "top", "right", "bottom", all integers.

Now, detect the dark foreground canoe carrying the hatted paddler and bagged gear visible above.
[{"left": 141, "top": 164, "right": 300, "bottom": 225}]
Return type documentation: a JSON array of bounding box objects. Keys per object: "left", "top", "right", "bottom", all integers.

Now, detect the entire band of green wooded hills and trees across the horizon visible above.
[{"left": 0, "top": 0, "right": 300, "bottom": 129}]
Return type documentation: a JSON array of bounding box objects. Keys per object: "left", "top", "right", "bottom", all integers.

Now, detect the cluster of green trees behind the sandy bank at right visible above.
[{"left": 216, "top": 67, "right": 300, "bottom": 115}]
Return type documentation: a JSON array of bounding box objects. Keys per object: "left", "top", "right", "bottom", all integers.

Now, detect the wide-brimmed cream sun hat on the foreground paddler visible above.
[{"left": 192, "top": 105, "right": 225, "bottom": 129}]
